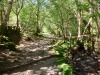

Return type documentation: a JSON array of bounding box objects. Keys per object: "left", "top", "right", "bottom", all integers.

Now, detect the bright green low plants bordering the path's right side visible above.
[{"left": 54, "top": 42, "right": 72, "bottom": 75}]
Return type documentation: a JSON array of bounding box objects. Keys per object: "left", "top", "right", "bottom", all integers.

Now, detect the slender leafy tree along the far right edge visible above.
[{"left": 88, "top": 0, "right": 100, "bottom": 50}]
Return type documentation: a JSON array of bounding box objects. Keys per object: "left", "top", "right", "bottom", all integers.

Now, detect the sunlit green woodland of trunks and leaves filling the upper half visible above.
[{"left": 0, "top": 0, "right": 100, "bottom": 51}]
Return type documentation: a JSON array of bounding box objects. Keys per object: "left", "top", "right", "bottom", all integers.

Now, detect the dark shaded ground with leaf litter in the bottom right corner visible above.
[{"left": 69, "top": 53, "right": 100, "bottom": 75}]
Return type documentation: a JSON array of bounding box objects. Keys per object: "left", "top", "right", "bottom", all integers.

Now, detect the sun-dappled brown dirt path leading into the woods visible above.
[{"left": 0, "top": 37, "right": 62, "bottom": 75}]
